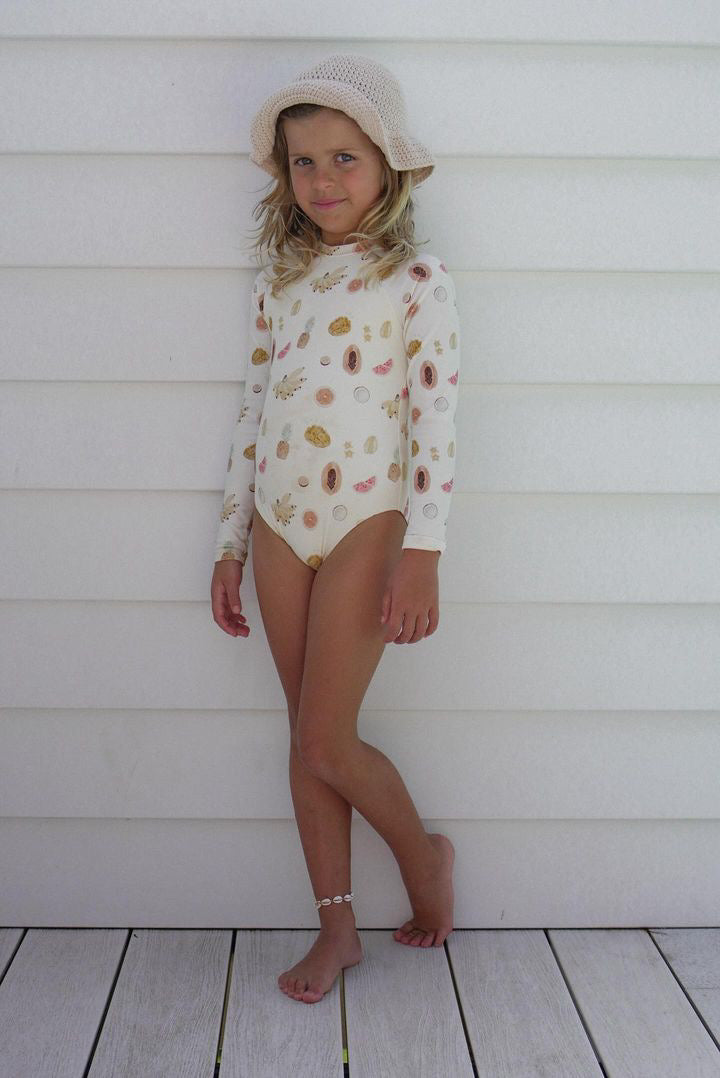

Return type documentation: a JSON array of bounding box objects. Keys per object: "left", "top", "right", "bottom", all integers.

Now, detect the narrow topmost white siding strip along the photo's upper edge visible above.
[{"left": 0, "top": 0, "right": 720, "bottom": 43}]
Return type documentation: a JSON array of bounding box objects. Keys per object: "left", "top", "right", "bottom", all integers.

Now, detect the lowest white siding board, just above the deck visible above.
[{"left": 0, "top": 818, "right": 720, "bottom": 929}]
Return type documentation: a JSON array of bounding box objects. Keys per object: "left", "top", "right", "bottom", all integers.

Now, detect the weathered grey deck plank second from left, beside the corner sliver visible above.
[{"left": 0, "top": 928, "right": 125, "bottom": 1078}]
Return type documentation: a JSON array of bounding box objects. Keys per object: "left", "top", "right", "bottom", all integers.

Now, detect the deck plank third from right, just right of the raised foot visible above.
[{"left": 447, "top": 928, "right": 603, "bottom": 1078}]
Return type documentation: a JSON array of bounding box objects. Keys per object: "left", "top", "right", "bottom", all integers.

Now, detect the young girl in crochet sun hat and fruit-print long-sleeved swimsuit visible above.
[{"left": 211, "top": 55, "right": 459, "bottom": 1003}]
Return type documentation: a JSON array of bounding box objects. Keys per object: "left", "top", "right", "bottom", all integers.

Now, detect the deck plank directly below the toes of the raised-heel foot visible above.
[{"left": 345, "top": 929, "right": 473, "bottom": 1078}]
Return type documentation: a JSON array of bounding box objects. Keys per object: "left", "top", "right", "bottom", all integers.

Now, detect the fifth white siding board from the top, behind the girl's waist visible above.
[{"left": 5, "top": 382, "right": 720, "bottom": 489}]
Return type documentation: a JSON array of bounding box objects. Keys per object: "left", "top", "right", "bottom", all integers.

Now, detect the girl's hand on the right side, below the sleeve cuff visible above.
[{"left": 380, "top": 547, "right": 440, "bottom": 644}]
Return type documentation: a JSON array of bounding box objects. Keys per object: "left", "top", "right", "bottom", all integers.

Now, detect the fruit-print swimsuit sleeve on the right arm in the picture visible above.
[{"left": 402, "top": 254, "right": 460, "bottom": 553}]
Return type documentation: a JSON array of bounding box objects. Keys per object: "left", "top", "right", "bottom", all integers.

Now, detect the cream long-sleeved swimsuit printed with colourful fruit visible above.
[{"left": 214, "top": 244, "right": 460, "bottom": 569}]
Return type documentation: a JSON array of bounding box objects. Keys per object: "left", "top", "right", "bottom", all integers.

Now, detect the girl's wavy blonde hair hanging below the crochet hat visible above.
[{"left": 244, "top": 101, "right": 427, "bottom": 298}]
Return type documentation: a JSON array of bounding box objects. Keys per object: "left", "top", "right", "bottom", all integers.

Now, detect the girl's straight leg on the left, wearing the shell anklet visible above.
[{"left": 252, "top": 511, "right": 362, "bottom": 1003}]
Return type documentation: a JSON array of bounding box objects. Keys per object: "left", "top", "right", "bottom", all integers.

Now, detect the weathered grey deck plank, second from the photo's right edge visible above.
[{"left": 549, "top": 928, "right": 720, "bottom": 1078}]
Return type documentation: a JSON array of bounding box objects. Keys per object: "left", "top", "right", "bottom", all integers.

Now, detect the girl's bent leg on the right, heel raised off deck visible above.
[{"left": 296, "top": 510, "right": 454, "bottom": 946}]
